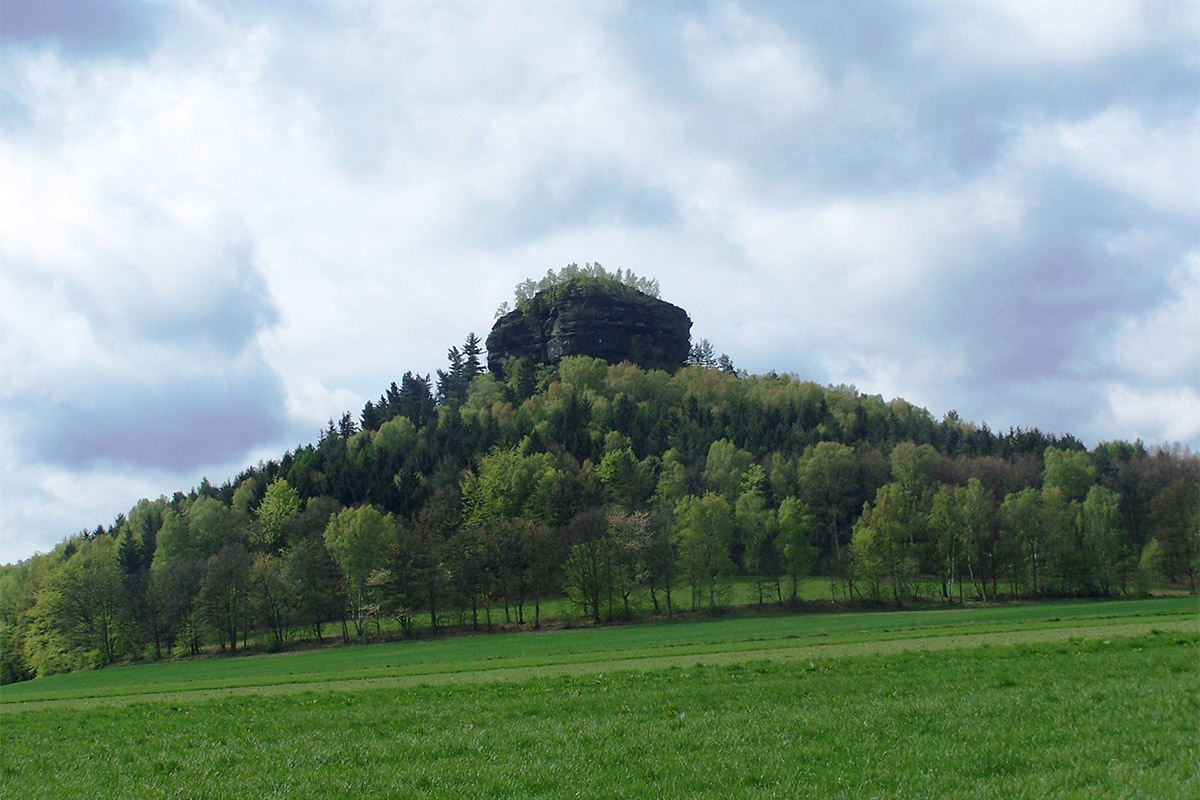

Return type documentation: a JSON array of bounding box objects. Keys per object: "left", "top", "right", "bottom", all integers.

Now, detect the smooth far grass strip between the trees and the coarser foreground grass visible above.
[{"left": 0, "top": 597, "right": 1200, "bottom": 714}]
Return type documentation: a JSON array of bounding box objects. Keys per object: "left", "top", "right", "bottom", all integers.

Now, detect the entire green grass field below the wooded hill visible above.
[{"left": 0, "top": 597, "right": 1200, "bottom": 798}]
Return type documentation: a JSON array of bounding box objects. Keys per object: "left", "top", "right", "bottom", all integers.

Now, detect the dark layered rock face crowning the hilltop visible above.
[{"left": 487, "top": 284, "right": 691, "bottom": 378}]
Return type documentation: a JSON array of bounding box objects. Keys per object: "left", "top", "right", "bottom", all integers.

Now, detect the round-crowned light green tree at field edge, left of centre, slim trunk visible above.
[{"left": 325, "top": 506, "right": 396, "bottom": 638}]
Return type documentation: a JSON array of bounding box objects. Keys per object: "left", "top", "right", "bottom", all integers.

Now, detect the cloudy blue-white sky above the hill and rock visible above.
[{"left": 0, "top": 0, "right": 1200, "bottom": 563}]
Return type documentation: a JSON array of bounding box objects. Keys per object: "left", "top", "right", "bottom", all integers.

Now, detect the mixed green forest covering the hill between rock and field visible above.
[{"left": 0, "top": 350, "right": 1200, "bottom": 681}]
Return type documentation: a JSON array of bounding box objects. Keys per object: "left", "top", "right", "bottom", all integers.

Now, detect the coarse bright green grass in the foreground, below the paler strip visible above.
[{"left": 0, "top": 630, "right": 1200, "bottom": 798}]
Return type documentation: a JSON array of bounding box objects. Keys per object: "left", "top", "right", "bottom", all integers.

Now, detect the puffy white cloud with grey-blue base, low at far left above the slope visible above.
[{"left": 0, "top": 214, "right": 283, "bottom": 469}]
